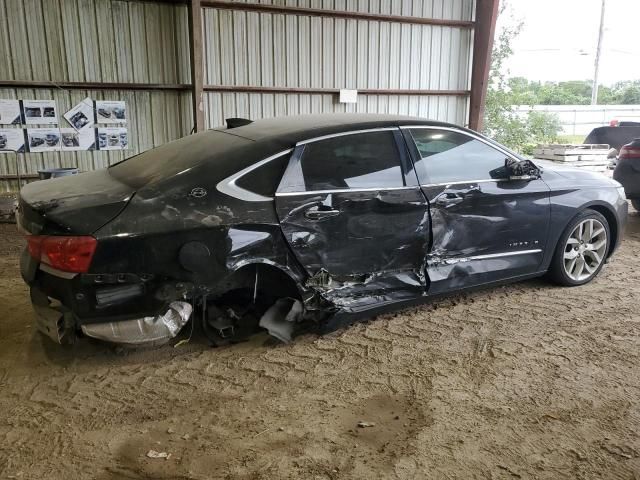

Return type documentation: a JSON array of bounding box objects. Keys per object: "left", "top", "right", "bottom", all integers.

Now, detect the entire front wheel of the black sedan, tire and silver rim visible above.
[{"left": 549, "top": 209, "right": 611, "bottom": 287}]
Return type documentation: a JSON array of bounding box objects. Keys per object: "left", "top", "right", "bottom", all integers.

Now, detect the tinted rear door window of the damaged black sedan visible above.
[{"left": 286, "top": 131, "right": 404, "bottom": 192}]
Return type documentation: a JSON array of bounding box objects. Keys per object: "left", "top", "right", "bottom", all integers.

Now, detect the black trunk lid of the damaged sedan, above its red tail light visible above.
[{"left": 19, "top": 169, "right": 135, "bottom": 235}]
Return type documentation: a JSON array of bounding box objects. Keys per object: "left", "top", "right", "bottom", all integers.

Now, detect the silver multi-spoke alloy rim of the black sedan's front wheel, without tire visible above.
[{"left": 564, "top": 218, "right": 607, "bottom": 282}]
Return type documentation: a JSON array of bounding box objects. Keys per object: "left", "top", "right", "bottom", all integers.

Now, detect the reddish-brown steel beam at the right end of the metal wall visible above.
[{"left": 469, "top": 0, "right": 499, "bottom": 131}]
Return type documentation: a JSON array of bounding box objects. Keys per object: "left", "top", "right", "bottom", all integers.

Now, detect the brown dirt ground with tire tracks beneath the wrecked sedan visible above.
[{"left": 0, "top": 212, "right": 640, "bottom": 480}]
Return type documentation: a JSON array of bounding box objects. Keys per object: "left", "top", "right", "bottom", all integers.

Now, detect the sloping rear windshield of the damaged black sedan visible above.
[{"left": 109, "top": 130, "right": 253, "bottom": 188}]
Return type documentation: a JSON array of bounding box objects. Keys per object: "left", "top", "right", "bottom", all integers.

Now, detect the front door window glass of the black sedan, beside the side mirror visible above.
[{"left": 410, "top": 128, "right": 507, "bottom": 184}]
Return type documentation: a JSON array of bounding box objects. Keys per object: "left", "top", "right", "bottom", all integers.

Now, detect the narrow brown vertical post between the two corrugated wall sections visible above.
[{"left": 189, "top": 0, "right": 204, "bottom": 132}]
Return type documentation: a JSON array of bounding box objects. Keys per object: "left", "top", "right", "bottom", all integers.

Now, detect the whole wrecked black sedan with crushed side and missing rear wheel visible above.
[{"left": 18, "top": 115, "right": 627, "bottom": 344}]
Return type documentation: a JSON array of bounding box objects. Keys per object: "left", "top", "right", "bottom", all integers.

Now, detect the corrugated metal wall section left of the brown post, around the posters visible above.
[{"left": 0, "top": 0, "right": 193, "bottom": 190}]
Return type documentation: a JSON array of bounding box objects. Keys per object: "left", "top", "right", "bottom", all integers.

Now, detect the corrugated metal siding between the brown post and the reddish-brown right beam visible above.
[{"left": 203, "top": 0, "right": 473, "bottom": 128}]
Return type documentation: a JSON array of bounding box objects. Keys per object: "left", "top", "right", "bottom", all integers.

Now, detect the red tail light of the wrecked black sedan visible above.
[{"left": 27, "top": 235, "right": 98, "bottom": 273}]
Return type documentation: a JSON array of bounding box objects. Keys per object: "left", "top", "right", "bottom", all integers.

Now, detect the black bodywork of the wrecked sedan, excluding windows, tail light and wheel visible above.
[{"left": 18, "top": 116, "right": 626, "bottom": 341}]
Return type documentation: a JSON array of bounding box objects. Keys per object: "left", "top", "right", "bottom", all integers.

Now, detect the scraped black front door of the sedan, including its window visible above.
[{"left": 403, "top": 127, "right": 550, "bottom": 293}]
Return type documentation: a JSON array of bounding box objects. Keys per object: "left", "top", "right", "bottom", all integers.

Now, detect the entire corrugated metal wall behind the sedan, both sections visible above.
[{"left": 0, "top": 0, "right": 474, "bottom": 190}]
